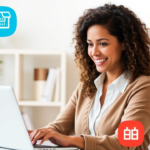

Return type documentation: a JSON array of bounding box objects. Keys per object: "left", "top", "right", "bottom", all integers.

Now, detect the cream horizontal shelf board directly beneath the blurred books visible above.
[{"left": 18, "top": 100, "right": 61, "bottom": 107}]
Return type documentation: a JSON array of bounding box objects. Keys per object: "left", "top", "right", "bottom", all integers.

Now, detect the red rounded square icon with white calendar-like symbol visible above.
[{"left": 118, "top": 120, "right": 144, "bottom": 147}]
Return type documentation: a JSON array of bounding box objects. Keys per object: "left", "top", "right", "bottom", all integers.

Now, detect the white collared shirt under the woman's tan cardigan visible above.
[{"left": 89, "top": 73, "right": 129, "bottom": 136}]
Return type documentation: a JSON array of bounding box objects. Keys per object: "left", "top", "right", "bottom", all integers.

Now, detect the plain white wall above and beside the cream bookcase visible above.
[{"left": 0, "top": 0, "right": 150, "bottom": 127}]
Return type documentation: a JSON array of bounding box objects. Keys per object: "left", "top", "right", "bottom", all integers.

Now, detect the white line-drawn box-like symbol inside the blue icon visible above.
[{"left": 0, "top": 11, "right": 11, "bottom": 29}]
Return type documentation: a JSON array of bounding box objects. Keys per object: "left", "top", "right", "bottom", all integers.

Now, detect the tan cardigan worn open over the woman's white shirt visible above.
[{"left": 48, "top": 75, "right": 150, "bottom": 150}]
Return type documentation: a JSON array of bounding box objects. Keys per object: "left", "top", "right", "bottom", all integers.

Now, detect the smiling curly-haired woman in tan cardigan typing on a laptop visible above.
[{"left": 29, "top": 4, "right": 150, "bottom": 150}]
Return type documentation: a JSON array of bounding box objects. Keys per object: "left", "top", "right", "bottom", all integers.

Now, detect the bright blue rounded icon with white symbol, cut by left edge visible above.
[{"left": 0, "top": 6, "right": 17, "bottom": 37}]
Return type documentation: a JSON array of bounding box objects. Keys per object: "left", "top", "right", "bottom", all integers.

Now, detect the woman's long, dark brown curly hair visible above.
[{"left": 73, "top": 4, "right": 150, "bottom": 96}]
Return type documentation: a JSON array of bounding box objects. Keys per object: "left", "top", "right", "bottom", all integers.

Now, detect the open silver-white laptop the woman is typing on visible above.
[{"left": 0, "top": 86, "right": 79, "bottom": 150}]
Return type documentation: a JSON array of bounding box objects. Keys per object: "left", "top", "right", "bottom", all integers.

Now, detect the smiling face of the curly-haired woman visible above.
[{"left": 87, "top": 25, "right": 124, "bottom": 72}]
